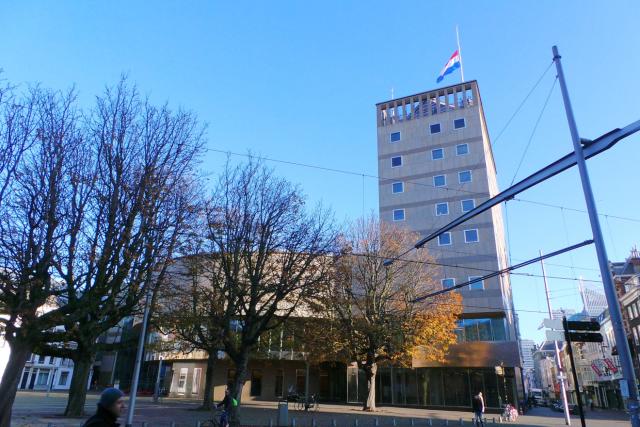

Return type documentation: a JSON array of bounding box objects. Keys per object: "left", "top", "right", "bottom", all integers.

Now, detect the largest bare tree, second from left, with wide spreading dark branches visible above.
[{"left": 0, "top": 79, "right": 203, "bottom": 427}]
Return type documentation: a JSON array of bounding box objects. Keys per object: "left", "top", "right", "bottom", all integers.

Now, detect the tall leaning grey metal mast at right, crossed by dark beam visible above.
[{"left": 553, "top": 46, "right": 640, "bottom": 427}]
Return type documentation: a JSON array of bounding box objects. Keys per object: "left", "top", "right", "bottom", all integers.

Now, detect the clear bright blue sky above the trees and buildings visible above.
[{"left": 0, "top": 1, "right": 640, "bottom": 340}]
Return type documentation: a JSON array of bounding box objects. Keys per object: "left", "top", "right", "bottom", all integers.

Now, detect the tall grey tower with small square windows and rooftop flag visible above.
[{"left": 376, "top": 81, "right": 521, "bottom": 408}]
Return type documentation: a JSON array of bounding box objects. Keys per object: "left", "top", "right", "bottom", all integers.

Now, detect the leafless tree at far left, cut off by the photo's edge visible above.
[{"left": 0, "top": 88, "right": 81, "bottom": 427}]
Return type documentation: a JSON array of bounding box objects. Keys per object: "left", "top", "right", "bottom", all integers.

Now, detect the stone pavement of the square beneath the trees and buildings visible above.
[{"left": 11, "top": 392, "right": 629, "bottom": 427}]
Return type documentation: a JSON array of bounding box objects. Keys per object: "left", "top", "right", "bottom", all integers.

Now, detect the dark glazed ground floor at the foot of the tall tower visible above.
[{"left": 347, "top": 367, "right": 515, "bottom": 408}]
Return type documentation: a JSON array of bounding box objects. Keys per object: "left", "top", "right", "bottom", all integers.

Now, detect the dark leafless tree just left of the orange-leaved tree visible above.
[{"left": 206, "top": 160, "right": 335, "bottom": 425}]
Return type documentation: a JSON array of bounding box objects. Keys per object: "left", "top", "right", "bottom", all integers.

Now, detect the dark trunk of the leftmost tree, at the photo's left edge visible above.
[{"left": 0, "top": 340, "right": 31, "bottom": 427}]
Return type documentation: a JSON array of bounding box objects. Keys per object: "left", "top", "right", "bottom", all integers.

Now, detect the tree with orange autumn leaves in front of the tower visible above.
[{"left": 318, "top": 217, "right": 462, "bottom": 411}]
